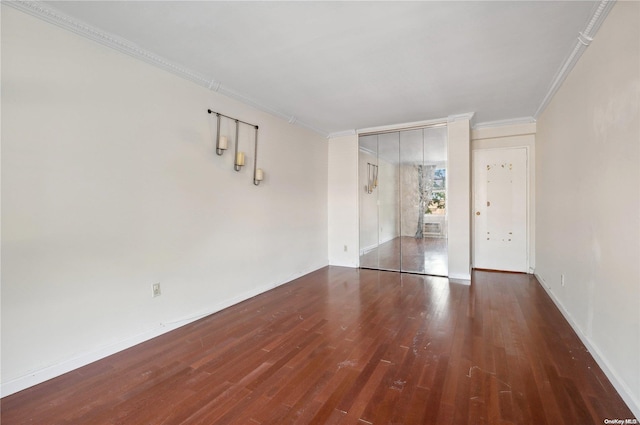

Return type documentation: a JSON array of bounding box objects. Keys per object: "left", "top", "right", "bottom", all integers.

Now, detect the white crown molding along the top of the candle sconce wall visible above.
[{"left": 2, "top": 0, "right": 329, "bottom": 137}]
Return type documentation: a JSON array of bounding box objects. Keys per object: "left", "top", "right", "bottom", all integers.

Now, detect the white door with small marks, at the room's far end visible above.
[{"left": 473, "top": 148, "right": 529, "bottom": 272}]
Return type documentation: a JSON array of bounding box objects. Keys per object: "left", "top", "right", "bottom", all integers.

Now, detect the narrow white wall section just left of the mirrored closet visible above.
[{"left": 328, "top": 134, "right": 360, "bottom": 267}]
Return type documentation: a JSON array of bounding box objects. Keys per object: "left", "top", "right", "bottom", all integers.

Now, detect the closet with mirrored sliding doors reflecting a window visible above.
[{"left": 358, "top": 124, "right": 448, "bottom": 276}]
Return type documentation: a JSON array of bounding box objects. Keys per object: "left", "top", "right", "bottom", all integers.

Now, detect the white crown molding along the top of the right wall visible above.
[{"left": 533, "top": 0, "right": 616, "bottom": 119}]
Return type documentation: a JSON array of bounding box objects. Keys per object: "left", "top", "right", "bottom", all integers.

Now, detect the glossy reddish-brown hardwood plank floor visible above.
[{"left": 1, "top": 267, "right": 633, "bottom": 425}]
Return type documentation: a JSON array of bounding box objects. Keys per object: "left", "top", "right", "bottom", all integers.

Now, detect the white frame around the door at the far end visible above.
[{"left": 471, "top": 145, "right": 533, "bottom": 274}]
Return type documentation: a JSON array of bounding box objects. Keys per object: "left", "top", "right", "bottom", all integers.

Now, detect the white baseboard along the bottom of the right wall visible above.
[{"left": 534, "top": 273, "right": 640, "bottom": 419}]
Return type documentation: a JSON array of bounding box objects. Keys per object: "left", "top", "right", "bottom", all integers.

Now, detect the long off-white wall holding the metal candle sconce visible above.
[{"left": 2, "top": 5, "right": 324, "bottom": 395}]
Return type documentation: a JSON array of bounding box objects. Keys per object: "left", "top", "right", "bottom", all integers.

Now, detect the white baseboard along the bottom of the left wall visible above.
[{"left": 0, "top": 263, "right": 327, "bottom": 397}]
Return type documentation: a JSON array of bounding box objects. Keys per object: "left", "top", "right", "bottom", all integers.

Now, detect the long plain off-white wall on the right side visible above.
[{"left": 536, "top": 2, "right": 640, "bottom": 417}]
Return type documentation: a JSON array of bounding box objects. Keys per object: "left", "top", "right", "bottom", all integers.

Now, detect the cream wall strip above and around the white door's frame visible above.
[{"left": 471, "top": 123, "right": 536, "bottom": 272}]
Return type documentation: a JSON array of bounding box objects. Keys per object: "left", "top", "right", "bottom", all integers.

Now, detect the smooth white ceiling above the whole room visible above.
[{"left": 22, "top": 1, "right": 602, "bottom": 135}]
